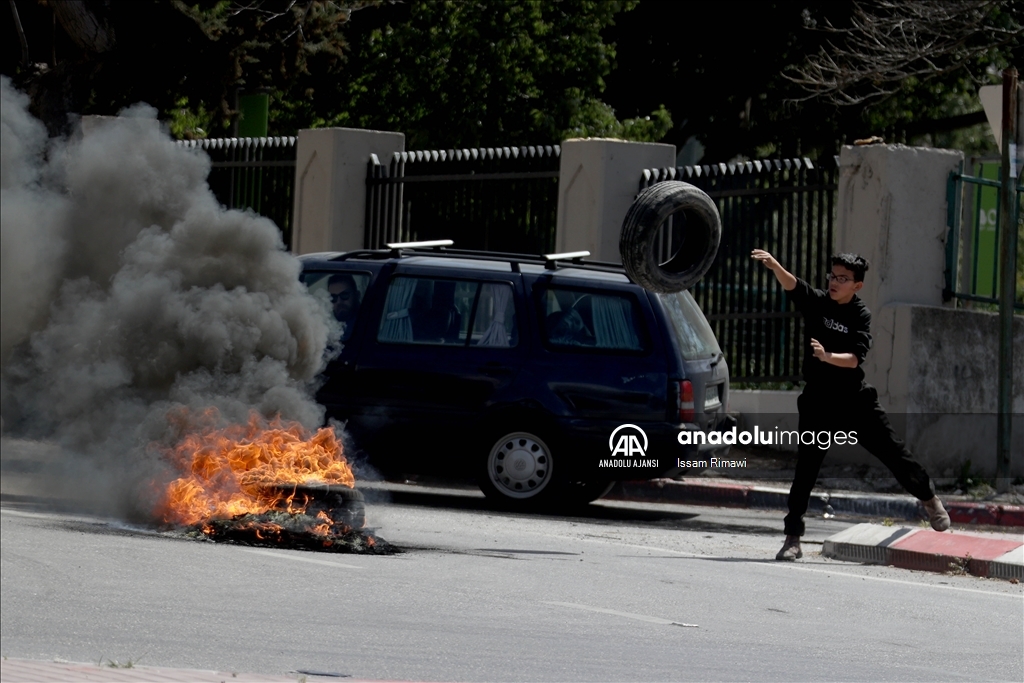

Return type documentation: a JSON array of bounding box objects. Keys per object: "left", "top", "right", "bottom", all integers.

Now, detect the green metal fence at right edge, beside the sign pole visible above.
[{"left": 943, "top": 158, "right": 1024, "bottom": 310}]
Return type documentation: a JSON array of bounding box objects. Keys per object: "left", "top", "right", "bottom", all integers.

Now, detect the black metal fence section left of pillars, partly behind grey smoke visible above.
[{"left": 178, "top": 137, "right": 296, "bottom": 247}]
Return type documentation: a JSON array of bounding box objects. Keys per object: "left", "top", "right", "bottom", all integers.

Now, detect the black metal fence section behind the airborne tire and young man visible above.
[{"left": 640, "top": 158, "right": 839, "bottom": 385}]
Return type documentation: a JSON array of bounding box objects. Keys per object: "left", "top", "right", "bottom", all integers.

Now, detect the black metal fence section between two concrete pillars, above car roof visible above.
[{"left": 364, "top": 144, "right": 561, "bottom": 254}]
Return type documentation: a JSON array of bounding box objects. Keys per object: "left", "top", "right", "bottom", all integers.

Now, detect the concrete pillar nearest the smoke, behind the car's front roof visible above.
[{"left": 292, "top": 128, "right": 406, "bottom": 254}]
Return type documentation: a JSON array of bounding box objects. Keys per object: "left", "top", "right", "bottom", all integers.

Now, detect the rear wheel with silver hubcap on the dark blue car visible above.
[{"left": 480, "top": 431, "right": 554, "bottom": 502}]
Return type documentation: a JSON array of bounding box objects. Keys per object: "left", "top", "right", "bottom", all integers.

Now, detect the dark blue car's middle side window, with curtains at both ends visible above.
[{"left": 377, "top": 275, "right": 517, "bottom": 347}]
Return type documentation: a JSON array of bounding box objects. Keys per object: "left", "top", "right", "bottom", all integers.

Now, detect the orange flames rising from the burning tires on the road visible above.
[{"left": 160, "top": 410, "right": 355, "bottom": 533}]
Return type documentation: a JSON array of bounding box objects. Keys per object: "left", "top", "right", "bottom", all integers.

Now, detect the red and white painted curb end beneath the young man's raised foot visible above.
[{"left": 821, "top": 524, "right": 1024, "bottom": 581}]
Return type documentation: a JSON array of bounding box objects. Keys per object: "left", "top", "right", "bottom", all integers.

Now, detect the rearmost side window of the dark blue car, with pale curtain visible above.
[{"left": 541, "top": 288, "right": 643, "bottom": 351}]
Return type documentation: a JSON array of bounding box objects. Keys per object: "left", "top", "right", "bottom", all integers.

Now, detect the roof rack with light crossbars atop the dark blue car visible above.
[{"left": 331, "top": 240, "right": 624, "bottom": 273}]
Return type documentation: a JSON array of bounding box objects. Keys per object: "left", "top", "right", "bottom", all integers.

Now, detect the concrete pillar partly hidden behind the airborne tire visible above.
[{"left": 555, "top": 138, "right": 676, "bottom": 263}]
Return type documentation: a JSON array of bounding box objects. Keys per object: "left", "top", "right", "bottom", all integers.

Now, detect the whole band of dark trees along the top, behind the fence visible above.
[{"left": 2, "top": 0, "right": 1024, "bottom": 156}]
